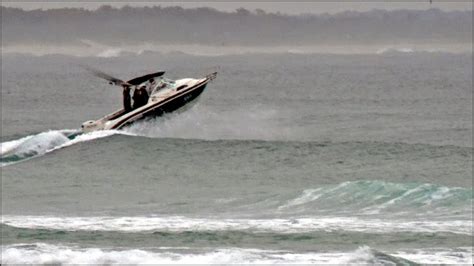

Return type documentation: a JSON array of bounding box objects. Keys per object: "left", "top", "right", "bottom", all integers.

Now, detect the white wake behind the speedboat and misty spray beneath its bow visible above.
[{"left": 0, "top": 103, "right": 287, "bottom": 167}]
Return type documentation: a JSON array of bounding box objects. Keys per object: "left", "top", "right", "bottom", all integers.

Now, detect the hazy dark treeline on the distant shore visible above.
[{"left": 2, "top": 6, "right": 472, "bottom": 45}]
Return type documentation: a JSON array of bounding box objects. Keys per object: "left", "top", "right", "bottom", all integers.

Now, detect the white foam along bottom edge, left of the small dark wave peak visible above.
[{"left": 2, "top": 244, "right": 330, "bottom": 264}]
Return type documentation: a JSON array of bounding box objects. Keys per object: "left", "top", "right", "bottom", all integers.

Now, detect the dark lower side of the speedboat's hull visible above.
[{"left": 111, "top": 80, "right": 208, "bottom": 129}]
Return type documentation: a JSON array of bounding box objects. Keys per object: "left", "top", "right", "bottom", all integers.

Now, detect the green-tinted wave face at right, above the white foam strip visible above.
[{"left": 278, "top": 180, "right": 473, "bottom": 217}]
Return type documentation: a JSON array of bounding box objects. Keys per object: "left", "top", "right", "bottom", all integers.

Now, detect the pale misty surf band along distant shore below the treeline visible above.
[{"left": 1, "top": 40, "right": 472, "bottom": 57}]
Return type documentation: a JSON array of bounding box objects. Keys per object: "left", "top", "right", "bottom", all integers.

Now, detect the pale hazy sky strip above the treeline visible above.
[{"left": 2, "top": 0, "right": 472, "bottom": 14}]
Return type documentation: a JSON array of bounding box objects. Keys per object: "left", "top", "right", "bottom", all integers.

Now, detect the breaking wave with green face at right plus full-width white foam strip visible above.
[{"left": 2, "top": 180, "right": 473, "bottom": 235}]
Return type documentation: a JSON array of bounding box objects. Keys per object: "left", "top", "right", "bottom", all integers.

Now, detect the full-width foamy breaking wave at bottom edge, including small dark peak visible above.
[{"left": 2, "top": 243, "right": 472, "bottom": 265}]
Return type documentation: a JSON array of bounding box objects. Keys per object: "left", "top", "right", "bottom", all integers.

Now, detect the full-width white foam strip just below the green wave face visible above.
[{"left": 2, "top": 215, "right": 472, "bottom": 235}]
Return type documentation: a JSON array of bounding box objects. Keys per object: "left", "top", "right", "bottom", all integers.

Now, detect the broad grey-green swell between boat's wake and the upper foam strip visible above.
[{"left": 2, "top": 134, "right": 473, "bottom": 219}]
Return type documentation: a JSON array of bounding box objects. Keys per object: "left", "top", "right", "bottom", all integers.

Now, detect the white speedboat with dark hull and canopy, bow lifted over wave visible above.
[{"left": 81, "top": 70, "right": 217, "bottom": 133}]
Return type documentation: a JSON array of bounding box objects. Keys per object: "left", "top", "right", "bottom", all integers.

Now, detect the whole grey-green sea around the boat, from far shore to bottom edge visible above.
[{"left": 1, "top": 50, "right": 473, "bottom": 265}]
